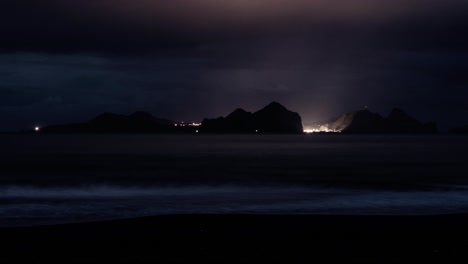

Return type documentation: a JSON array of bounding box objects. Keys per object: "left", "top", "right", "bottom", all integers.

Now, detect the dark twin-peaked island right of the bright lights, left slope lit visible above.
[{"left": 319, "top": 108, "right": 437, "bottom": 134}]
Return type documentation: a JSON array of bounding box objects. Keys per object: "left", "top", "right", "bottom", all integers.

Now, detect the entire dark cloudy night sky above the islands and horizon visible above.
[{"left": 0, "top": 0, "right": 468, "bottom": 131}]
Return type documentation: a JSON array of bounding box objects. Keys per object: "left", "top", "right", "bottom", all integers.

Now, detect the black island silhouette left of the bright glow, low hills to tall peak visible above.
[{"left": 36, "top": 102, "right": 303, "bottom": 134}]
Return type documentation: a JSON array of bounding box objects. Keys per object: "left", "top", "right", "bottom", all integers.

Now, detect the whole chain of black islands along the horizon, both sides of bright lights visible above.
[{"left": 34, "top": 102, "right": 452, "bottom": 134}]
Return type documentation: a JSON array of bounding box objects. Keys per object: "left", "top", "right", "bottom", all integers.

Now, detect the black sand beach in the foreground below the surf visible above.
[{"left": 0, "top": 214, "right": 468, "bottom": 263}]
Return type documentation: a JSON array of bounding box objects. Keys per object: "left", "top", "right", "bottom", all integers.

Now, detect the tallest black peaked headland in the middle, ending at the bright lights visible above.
[{"left": 201, "top": 102, "right": 303, "bottom": 134}]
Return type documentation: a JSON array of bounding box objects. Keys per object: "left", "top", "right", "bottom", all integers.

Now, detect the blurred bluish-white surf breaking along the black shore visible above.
[{"left": 0, "top": 186, "right": 468, "bottom": 226}]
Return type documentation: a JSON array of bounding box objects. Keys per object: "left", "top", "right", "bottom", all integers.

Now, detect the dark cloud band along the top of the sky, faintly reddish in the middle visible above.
[{"left": 0, "top": 0, "right": 468, "bottom": 53}]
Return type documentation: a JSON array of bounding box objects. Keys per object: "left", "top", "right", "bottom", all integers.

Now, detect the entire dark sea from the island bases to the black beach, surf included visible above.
[{"left": 0, "top": 134, "right": 468, "bottom": 226}]
